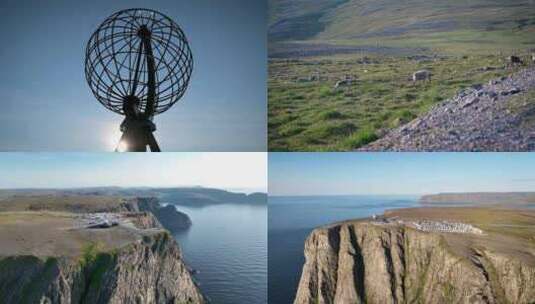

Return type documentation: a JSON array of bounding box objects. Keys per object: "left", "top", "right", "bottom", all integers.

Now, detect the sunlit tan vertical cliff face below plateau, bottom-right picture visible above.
[{"left": 294, "top": 222, "right": 535, "bottom": 304}]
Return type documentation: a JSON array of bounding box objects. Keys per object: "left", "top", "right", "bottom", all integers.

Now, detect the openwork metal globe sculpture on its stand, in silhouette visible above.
[{"left": 85, "top": 9, "right": 193, "bottom": 152}]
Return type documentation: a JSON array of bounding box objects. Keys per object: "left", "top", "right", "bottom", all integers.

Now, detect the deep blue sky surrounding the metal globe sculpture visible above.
[{"left": 0, "top": 0, "right": 267, "bottom": 151}]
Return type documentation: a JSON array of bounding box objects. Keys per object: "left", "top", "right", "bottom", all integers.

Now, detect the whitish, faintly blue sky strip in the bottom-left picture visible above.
[{"left": 0, "top": 152, "right": 267, "bottom": 192}]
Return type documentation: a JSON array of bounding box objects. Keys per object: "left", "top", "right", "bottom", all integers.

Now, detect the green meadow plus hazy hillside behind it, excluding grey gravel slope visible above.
[{"left": 268, "top": 0, "right": 535, "bottom": 151}]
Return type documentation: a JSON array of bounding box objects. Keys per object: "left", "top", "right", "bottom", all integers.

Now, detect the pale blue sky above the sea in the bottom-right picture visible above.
[{"left": 269, "top": 153, "right": 535, "bottom": 195}]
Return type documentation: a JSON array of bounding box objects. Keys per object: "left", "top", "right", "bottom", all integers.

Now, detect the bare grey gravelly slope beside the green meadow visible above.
[{"left": 361, "top": 67, "right": 535, "bottom": 151}]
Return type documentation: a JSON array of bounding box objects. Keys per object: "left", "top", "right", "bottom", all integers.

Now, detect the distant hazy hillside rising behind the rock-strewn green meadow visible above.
[{"left": 269, "top": 0, "right": 535, "bottom": 51}]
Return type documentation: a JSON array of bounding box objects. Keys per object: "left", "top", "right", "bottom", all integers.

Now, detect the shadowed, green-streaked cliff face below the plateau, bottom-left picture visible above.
[{"left": 0, "top": 231, "right": 204, "bottom": 304}]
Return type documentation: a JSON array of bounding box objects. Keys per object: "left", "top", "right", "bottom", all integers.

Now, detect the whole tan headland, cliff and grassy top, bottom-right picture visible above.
[{"left": 294, "top": 208, "right": 535, "bottom": 304}]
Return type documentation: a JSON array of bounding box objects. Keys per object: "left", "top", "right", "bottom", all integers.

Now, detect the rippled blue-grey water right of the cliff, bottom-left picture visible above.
[{"left": 171, "top": 204, "right": 267, "bottom": 304}]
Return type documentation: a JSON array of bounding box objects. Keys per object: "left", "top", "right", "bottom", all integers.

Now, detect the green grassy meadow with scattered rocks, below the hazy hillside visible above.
[{"left": 268, "top": 54, "right": 527, "bottom": 151}]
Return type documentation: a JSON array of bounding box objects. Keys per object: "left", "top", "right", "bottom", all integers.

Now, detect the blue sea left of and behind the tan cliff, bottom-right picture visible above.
[{"left": 268, "top": 196, "right": 418, "bottom": 304}]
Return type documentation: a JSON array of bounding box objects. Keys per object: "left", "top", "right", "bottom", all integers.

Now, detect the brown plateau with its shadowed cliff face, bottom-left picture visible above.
[{"left": 0, "top": 212, "right": 205, "bottom": 304}]
